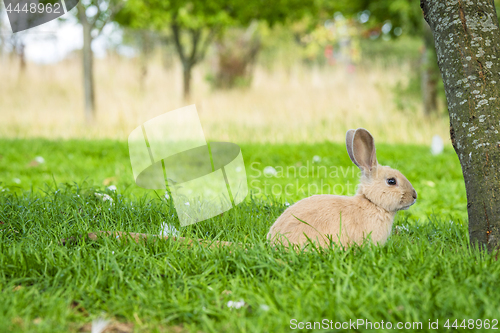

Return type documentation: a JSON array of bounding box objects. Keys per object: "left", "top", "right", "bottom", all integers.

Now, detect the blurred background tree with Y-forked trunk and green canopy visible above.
[{"left": 116, "top": 0, "right": 312, "bottom": 99}]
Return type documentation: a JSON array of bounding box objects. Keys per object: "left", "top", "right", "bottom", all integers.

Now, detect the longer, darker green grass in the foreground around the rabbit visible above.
[{"left": 0, "top": 182, "right": 500, "bottom": 332}]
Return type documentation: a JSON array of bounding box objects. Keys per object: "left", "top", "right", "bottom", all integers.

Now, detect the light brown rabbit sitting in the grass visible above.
[{"left": 267, "top": 128, "right": 417, "bottom": 246}]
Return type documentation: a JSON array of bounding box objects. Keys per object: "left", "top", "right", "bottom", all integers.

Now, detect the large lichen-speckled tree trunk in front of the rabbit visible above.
[{"left": 420, "top": 0, "right": 500, "bottom": 251}]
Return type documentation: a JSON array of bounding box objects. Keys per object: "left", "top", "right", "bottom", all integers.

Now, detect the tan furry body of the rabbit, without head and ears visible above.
[{"left": 267, "top": 194, "right": 394, "bottom": 246}]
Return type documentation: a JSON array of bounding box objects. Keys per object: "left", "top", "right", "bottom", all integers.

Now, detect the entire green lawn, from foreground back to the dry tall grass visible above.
[{"left": 0, "top": 139, "right": 500, "bottom": 332}]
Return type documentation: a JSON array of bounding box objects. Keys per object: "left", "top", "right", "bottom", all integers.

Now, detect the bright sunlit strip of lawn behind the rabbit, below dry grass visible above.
[{"left": 0, "top": 139, "right": 467, "bottom": 221}]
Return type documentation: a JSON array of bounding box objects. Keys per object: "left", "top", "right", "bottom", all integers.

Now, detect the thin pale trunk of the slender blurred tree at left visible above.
[{"left": 78, "top": 3, "right": 95, "bottom": 124}]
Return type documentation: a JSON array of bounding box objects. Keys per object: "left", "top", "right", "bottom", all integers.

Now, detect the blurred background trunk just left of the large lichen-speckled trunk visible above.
[{"left": 421, "top": 22, "right": 439, "bottom": 116}]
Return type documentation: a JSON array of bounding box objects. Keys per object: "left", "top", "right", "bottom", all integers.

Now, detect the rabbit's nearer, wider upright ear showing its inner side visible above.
[{"left": 349, "top": 128, "right": 378, "bottom": 172}]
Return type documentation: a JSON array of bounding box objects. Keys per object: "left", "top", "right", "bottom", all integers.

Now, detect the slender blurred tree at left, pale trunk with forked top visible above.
[{"left": 77, "top": 0, "right": 123, "bottom": 123}]
